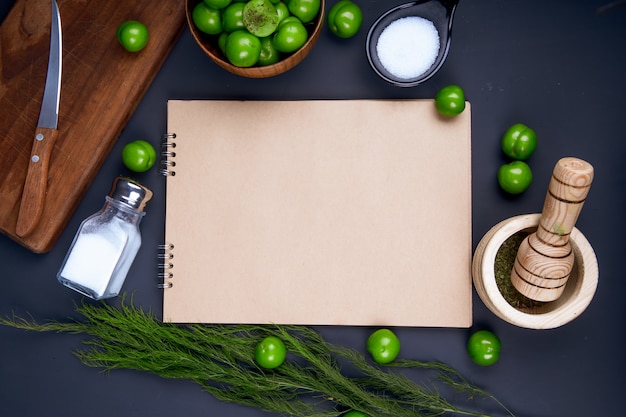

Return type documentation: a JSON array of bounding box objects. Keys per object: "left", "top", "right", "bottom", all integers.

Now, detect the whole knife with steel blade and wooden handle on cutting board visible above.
[{"left": 15, "top": 0, "right": 63, "bottom": 237}]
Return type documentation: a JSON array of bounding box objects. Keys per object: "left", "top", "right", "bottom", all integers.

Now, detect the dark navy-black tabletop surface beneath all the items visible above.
[{"left": 0, "top": 0, "right": 626, "bottom": 417}]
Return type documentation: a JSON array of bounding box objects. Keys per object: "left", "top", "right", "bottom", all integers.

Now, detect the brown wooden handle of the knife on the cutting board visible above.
[{"left": 15, "top": 127, "right": 59, "bottom": 237}]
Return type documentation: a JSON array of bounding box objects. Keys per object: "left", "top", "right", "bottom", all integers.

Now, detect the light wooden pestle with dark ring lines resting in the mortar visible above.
[{"left": 511, "top": 157, "right": 593, "bottom": 302}]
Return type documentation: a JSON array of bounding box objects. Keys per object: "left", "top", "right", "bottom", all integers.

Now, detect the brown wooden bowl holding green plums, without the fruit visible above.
[{"left": 185, "top": 0, "right": 325, "bottom": 78}]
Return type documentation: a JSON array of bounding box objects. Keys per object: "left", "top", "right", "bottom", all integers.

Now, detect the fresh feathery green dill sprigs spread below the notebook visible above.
[{"left": 0, "top": 299, "right": 513, "bottom": 417}]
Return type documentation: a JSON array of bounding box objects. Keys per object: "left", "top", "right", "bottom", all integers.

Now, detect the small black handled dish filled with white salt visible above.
[{"left": 366, "top": 0, "right": 459, "bottom": 87}]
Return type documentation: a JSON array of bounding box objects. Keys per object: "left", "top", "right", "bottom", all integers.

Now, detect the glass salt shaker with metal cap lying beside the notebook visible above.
[{"left": 57, "top": 177, "right": 152, "bottom": 300}]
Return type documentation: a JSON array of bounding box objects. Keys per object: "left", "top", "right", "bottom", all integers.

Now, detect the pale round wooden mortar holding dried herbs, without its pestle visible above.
[{"left": 472, "top": 214, "right": 598, "bottom": 329}]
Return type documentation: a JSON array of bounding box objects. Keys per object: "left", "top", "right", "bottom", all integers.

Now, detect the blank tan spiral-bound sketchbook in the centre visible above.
[{"left": 159, "top": 100, "right": 472, "bottom": 327}]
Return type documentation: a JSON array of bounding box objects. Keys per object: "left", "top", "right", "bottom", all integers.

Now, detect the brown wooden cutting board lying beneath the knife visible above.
[{"left": 0, "top": 0, "right": 185, "bottom": 253}]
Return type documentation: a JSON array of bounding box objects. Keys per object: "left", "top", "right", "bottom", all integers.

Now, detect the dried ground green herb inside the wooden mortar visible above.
[{"left": 494, "top": 231, "right": 545, "bottom": 311}]
